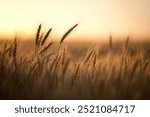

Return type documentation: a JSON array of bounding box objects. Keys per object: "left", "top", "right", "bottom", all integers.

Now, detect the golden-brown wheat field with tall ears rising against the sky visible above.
[{"left": 0, "top": 24, "right": 150, "bottom": 99}]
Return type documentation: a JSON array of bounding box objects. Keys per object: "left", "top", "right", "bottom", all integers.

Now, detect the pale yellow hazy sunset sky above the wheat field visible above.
[{"left": 0, "top": 0, "right": 150, "bottom": 39}]
